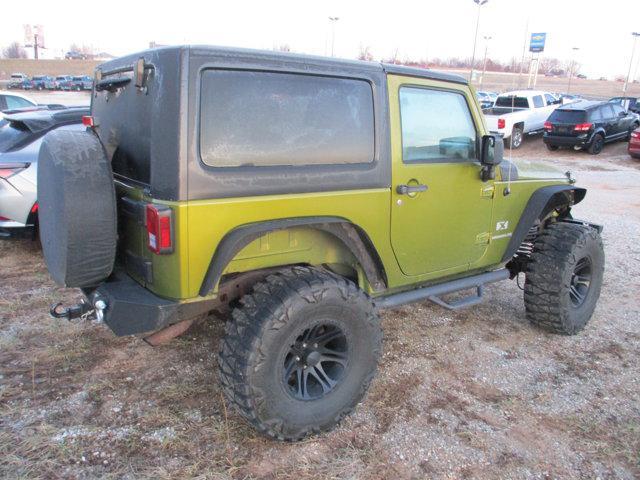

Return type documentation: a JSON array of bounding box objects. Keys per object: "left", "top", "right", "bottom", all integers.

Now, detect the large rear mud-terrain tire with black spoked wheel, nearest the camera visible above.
[{"left": 218, "top": 267, "right": 382, "bottom": 441}]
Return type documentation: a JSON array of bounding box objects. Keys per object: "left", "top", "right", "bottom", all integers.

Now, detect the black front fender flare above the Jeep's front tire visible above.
[{"left": 501, "top": 185, "right": 587, "bottom": 262}]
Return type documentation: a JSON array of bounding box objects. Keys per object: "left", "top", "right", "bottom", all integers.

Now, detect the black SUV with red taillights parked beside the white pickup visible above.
[{"left": 543, "top": 101, "right": 640, "bottom": 155}]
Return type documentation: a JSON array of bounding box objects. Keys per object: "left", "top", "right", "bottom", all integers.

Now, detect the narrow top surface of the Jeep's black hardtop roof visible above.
[{"left": 98, "top": 45, "right": 468, "bottom": 85}]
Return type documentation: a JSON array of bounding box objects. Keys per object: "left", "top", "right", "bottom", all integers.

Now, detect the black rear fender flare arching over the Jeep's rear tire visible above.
[{"left": 200, "top": 216, "right": 387, "bottom": 296}]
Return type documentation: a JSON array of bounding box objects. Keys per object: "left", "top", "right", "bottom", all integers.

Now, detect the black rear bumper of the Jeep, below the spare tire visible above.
[{"left": 84, "top": 272, "right": 217, "bottom": 336}]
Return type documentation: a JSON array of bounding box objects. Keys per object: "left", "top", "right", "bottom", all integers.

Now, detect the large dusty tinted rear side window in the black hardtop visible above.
[{"left": 200, "top": 70, "right": 374, "bottom": 167}]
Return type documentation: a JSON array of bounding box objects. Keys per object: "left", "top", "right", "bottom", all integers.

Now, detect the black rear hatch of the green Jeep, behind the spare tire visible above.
[{"left": 91, "top": 48, "right": 186, "bottom": 293}]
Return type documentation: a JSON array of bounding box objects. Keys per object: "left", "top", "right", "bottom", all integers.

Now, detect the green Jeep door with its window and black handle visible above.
[{"left": 388, "top": 75, "right": 494, "bottom": 276}]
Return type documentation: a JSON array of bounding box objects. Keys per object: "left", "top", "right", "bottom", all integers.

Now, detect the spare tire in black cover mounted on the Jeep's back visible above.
[{"left": 38, "top": 130, "right": 117, "bottom": 287}]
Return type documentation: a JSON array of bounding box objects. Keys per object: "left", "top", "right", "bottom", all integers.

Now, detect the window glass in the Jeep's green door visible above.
[{"left": 400, "top": 87, "right": 476, "bottom": 163}]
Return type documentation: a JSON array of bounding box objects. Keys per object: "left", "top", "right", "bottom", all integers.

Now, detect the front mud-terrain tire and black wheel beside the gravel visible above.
[{"left": 524, "top": 222, "right": 604, "bottom": 335}]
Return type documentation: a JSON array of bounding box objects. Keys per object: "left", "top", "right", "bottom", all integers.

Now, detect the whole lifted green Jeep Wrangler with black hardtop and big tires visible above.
[{"left": 38, "top": 46, "right": 604, "bottom": 440}]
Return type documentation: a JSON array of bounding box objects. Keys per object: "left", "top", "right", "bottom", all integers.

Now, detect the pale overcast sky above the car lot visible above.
[{"left": 0, "top": 0, "right": 640, "bottom": 78}]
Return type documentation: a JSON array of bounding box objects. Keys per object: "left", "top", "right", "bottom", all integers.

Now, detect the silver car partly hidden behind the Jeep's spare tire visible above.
[{"left": 0, "top": 107, "right": 89, "bottom": 237}]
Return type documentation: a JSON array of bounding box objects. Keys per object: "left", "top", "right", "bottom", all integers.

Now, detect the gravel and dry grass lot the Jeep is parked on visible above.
[{"left": 0, "top": 139, "right": 640, "bottom": 479}]
